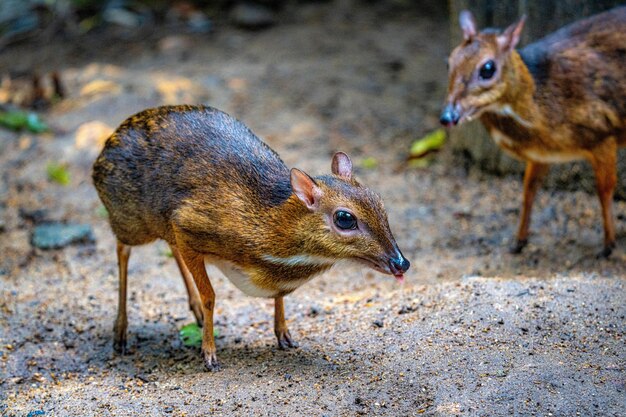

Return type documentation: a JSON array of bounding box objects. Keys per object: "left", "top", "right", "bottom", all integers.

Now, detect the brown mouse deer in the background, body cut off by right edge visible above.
[{"left": 441, "top": 7, "right": 626, "bottom": 256}]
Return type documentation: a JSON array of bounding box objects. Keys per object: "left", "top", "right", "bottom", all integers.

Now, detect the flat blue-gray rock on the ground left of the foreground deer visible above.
[{"left": 30, "top": 223, "right": 96, "bottom": 249}]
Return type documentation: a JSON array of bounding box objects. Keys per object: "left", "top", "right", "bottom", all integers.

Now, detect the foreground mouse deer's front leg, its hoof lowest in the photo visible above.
[{"left": 180, "top": 247, "right": 219, "bottom": 371}]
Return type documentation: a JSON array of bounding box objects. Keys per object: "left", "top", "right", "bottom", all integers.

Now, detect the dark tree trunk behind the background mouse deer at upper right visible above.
[{"left": 450, "top": 0, "right": 626, "bottom": 199}]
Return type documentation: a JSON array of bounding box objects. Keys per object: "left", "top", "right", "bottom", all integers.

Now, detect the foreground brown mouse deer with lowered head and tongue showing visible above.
[{"left": 93, "top": 106, "right": 409, "bottom": 369}]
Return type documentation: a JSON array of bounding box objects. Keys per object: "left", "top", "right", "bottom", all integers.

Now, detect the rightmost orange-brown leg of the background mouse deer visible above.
[{"left": 590, "top": 137, "right": 617, "bottom": 258}]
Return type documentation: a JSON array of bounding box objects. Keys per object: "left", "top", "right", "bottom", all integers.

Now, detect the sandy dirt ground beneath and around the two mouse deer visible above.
[{"left": 0, "top": 2, "right": 626, "bottom": 416}]
